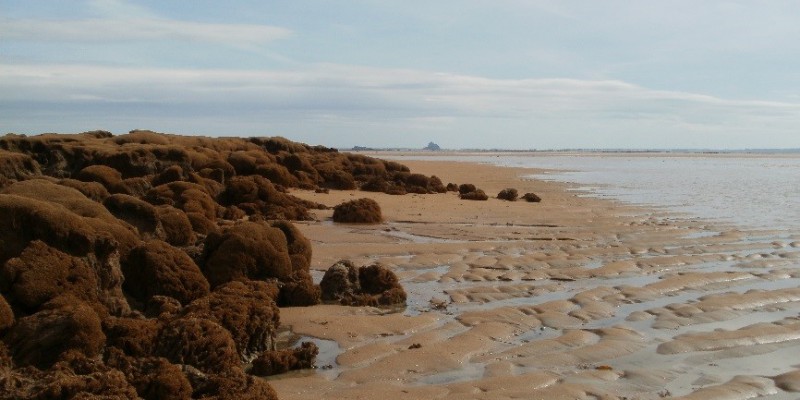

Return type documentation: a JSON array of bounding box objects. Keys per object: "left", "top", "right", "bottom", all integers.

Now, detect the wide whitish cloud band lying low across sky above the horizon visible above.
[{"left": 0, "top": 64, "right": 800, "bottom": 147}]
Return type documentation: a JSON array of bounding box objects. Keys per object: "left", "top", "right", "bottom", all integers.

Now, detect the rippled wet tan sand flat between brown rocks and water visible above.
[{"left": 270, "top": 160, "right": 800, "bottom": 399}]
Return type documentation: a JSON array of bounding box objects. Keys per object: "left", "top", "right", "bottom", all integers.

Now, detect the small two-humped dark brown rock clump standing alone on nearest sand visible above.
[{"left": 320, "top": 260, "right": 406, "bottom": 306}]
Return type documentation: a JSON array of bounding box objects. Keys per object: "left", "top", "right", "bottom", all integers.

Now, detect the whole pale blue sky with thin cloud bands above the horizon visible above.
[{"left": 0, "top": 0, "right": 800, "bottom": 149}]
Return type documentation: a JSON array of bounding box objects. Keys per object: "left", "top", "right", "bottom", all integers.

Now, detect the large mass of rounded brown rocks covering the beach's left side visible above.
[{"left": 0, "top": 131, "right": 422, "bottom": 399}]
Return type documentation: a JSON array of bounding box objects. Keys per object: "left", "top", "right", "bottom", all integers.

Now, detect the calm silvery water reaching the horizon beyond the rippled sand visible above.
[{"left": 390, "top": 153, "right": 800, "bottom": 233}]
